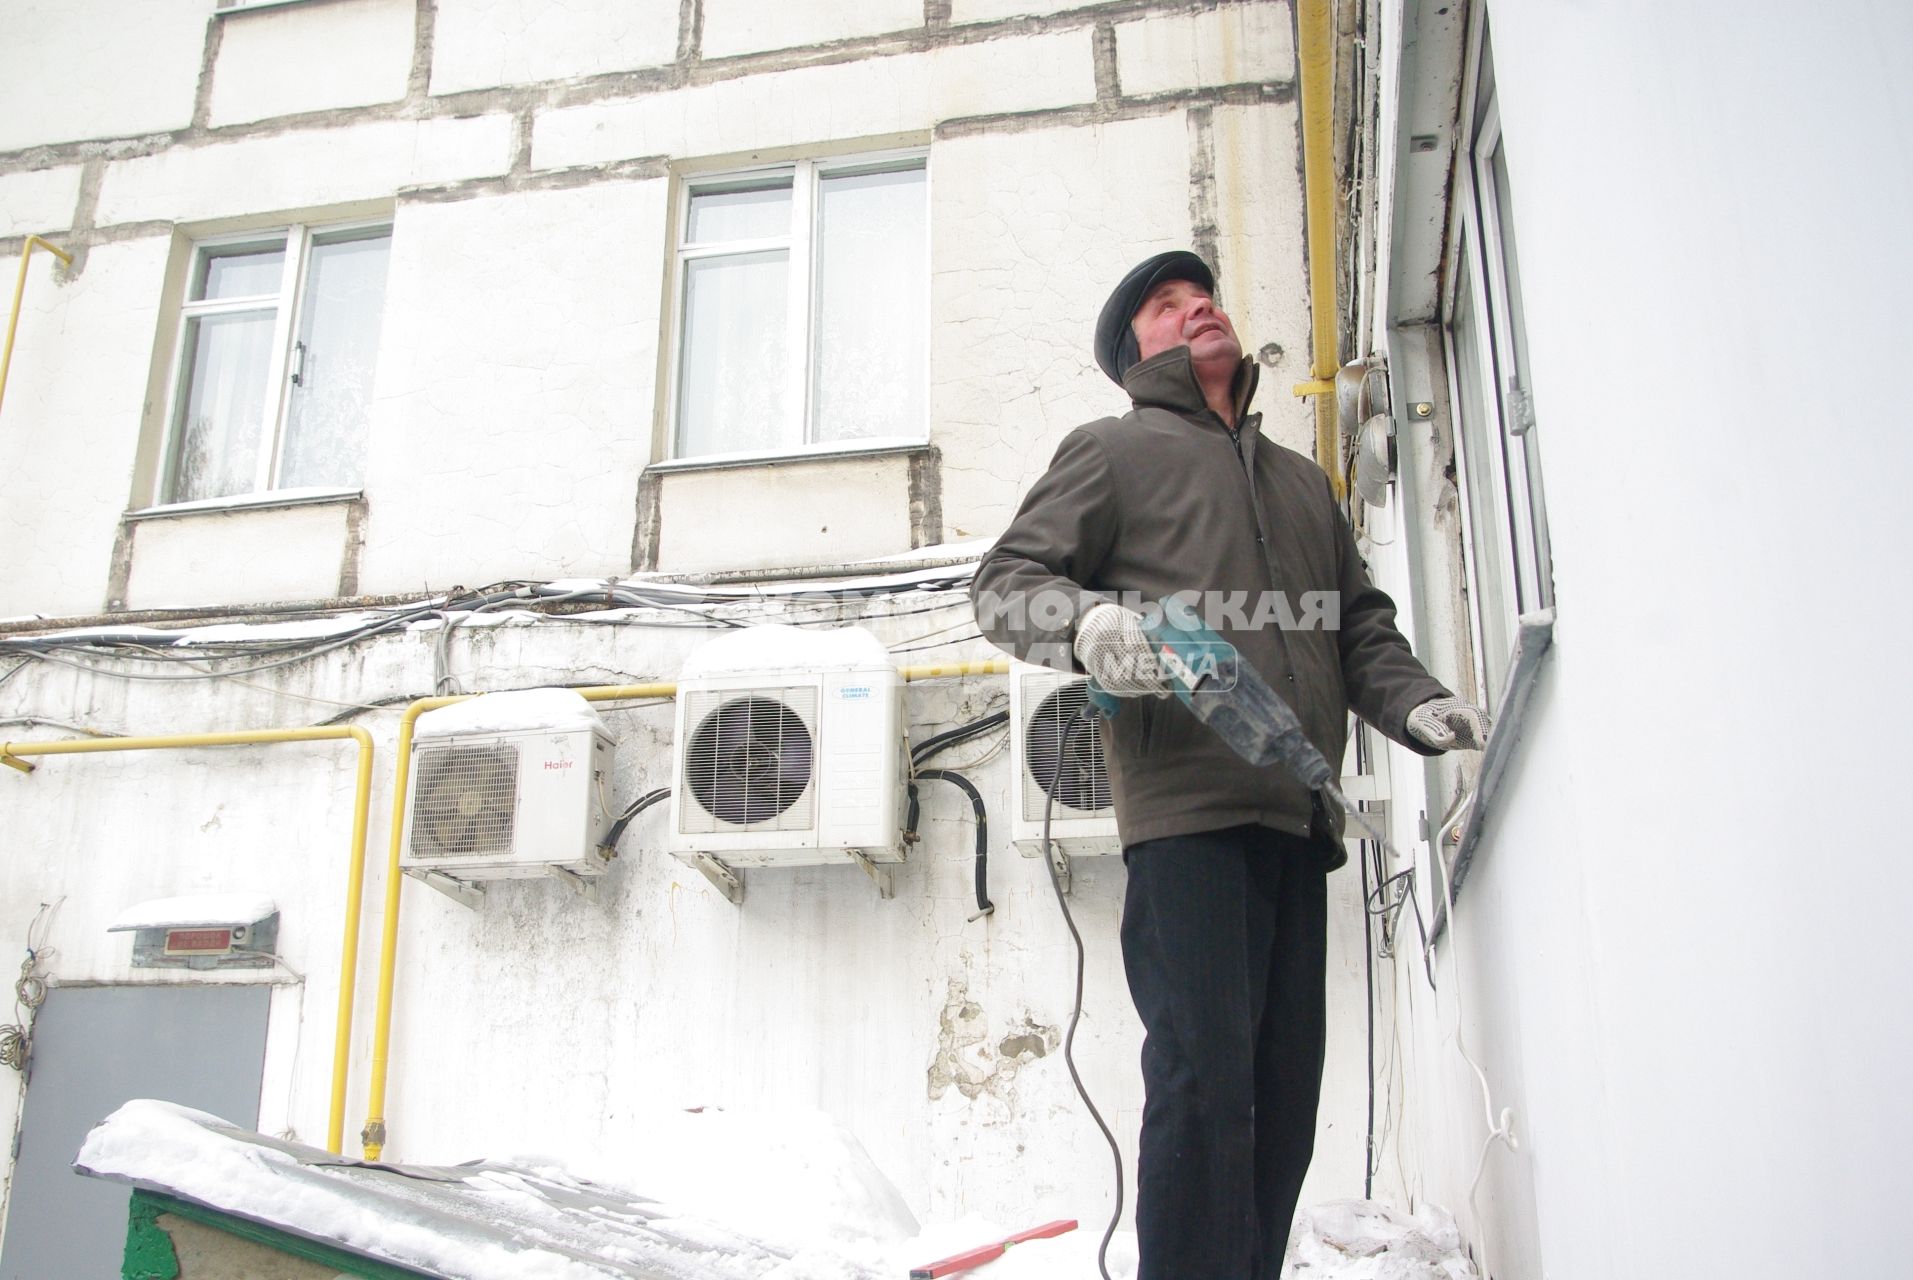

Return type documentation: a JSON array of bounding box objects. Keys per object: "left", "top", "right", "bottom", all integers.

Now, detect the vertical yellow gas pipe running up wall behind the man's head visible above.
[{"left": 1293, "top": 0, "right": 1347, "bottom": 501}]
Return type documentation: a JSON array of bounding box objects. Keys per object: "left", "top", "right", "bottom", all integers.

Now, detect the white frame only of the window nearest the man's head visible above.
[{"left": 666, "top": 147, "right": 932, "bottom": 465}]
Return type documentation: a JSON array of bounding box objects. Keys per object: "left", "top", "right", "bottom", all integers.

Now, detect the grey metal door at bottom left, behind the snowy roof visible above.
[{"left": 0, "top": 983, "right": 272, "bottom": 1280}]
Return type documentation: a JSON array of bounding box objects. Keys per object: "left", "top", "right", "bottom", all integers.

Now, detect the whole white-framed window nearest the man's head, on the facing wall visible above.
[{"left": 671, "top": 155, "right": 930, "bottom": 457}]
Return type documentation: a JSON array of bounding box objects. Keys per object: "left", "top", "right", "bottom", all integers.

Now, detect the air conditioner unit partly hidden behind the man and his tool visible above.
[{"left": 1010, "top": 662, "right": 1123, "bottom": 888}]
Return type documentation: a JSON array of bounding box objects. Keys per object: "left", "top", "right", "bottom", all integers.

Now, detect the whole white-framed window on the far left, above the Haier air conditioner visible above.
[{"left": 161, "top": 224, "right": 392, "bottom": 503}]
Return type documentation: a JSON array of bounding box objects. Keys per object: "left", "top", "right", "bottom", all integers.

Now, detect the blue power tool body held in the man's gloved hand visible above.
[{"left": 1088, "top": 597, "right": 1339, "bottom": 796}]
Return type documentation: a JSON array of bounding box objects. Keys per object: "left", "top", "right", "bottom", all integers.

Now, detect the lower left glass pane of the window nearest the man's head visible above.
[{"left": 677, "top": 249, "right": 790, "bottom": 455}]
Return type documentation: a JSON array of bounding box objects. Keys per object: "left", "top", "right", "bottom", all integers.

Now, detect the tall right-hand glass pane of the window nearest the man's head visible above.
[{"left": 811, "top": 168, "right": 928, "bottom": 440}]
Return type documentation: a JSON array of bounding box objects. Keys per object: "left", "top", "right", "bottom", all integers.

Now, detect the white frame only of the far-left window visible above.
[{"left": 149, "top": 218, "right": 392, "bottom": 509}]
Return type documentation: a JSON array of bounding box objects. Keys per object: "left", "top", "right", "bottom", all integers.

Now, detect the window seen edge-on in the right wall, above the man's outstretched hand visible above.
[{"left": 1444, "top": 36, "right": 1553, "bottom": 710}]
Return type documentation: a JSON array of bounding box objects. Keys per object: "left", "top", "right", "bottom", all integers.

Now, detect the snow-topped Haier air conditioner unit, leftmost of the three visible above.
[{"left": 400, "top": 689, "right": 614, "bottom": 892}]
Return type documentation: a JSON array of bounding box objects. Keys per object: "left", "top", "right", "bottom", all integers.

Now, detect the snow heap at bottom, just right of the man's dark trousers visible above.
[{"left": 1282, "top": 1200, "right": 1475, "bottom": 1280}]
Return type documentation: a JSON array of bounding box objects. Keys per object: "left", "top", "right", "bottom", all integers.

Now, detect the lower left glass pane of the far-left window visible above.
[{"left": 172, "top": 312, "right": 275, "bottom": 501}]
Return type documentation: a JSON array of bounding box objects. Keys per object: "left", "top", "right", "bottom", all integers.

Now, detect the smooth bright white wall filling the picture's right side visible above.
[{"left": 1379, "top": 0, "right": 1913, "bottom": 1276}]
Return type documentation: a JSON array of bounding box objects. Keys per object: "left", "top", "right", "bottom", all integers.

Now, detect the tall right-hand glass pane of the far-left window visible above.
[{"left": 279, "top": 235, "right": 392, "bottom": 488}]
